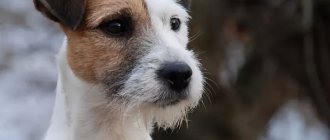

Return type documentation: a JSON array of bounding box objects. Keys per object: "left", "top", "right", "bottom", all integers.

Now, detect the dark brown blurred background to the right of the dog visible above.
[{"left": 154, "top": 0, "right": 330, "bottom": 140}]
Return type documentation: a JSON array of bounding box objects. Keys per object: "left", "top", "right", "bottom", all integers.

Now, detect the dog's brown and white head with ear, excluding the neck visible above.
[{"left": 34, "top": 0, "right": 203, "bottom": 126}]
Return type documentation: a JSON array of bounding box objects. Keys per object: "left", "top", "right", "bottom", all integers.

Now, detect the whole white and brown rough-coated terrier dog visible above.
[{"left": 34, "top": 0, "right": 204, "bottom": 140}]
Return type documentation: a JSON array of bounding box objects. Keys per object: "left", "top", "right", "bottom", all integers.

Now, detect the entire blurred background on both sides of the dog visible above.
[{"left": 0, "top": 0, "right": 330, "bottom": 140}]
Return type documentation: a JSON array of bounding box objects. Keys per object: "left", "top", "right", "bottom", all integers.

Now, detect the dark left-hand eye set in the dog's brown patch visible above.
[{"left": 99, "top": 18, "right": 132, "bottom": 37}]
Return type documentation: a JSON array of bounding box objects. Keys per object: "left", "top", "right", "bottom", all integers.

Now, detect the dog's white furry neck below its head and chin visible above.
[{"left": 45, "top": 40, "right": 152, "bottom": 140}]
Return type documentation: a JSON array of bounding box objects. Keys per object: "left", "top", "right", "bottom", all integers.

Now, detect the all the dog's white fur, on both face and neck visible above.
[{"left": 45, "top": 0, "right": 204, "bottom": 140}]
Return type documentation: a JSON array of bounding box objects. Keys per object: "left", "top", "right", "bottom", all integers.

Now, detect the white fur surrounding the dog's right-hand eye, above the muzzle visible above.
[{"left": 145, "top": 0, "right": 190, "bottom": 47}]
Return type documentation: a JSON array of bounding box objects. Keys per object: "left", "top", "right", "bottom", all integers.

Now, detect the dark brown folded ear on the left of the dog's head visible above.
[{"left": 33, "top": 0, "right": 86, "bottom": 30}]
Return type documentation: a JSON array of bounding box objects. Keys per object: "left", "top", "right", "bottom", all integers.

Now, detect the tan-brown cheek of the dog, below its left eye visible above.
[{"left": 66, "top": 31, "right": 122, "bottom": 83}]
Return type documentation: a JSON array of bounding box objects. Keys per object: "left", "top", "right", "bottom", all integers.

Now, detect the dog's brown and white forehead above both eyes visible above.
[{"left": 86, "top": 0, "right": 188, "bottom": 27}]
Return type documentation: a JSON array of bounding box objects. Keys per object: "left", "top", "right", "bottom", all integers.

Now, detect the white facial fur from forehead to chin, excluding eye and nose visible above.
[{"left": 118, "top": 0, "right": 203, "bottom": 128}]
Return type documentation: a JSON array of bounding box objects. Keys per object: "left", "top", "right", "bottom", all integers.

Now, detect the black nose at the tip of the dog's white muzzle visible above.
[{"left": 157, "top": 62, "right": 192, "bottom": 92}]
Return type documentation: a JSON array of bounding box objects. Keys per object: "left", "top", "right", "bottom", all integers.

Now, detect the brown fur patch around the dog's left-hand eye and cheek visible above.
[{"left": 62, "top": 0, "right": 150, "bottom": 85}]
